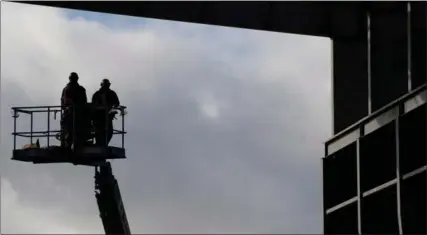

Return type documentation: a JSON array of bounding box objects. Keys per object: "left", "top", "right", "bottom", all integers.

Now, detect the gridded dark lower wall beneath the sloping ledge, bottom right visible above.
[{"left": 323, "top": 101, "right": 427, "bottom": 234}]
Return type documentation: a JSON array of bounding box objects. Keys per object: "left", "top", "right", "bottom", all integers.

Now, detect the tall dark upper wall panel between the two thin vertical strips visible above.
[{"left": 371, "top": 2, "right": 408, "bottom": 111}]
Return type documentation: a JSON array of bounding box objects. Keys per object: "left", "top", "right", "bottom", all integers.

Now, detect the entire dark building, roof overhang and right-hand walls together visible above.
[{"left": 8, "top": 1, "right": 427, "bottom": 234}]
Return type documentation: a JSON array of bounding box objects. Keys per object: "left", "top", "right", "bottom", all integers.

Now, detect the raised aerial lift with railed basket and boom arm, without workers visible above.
[{"left": 12, "top": 104, "right": 130, "bottom": 234}]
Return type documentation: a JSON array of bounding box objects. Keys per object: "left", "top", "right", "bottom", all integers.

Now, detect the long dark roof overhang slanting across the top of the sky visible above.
[{"left": 10, "top": 1, "right": 372, "bottom": 38}]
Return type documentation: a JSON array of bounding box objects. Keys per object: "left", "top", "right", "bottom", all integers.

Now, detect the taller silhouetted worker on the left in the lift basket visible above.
[{"left": 61, "top": 72, "right": 89, "bottom": 148}]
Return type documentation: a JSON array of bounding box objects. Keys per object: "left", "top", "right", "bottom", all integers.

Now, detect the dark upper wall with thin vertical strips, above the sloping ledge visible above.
[{"left": 333, "top": 2, "right": 427, "bottom": 133}]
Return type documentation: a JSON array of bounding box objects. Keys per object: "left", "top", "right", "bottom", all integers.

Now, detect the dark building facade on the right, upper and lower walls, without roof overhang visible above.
[{"left": 323, "top": 2, "right": 427, "bottom": 234}]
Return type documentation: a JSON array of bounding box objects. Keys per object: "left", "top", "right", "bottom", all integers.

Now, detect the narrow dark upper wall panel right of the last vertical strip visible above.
[{"left": 411, "top": 1, "right": 427, "bottom": 88}]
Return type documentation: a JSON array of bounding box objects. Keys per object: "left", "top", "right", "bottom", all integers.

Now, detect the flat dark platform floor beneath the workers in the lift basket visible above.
[{"left": 12, "top": 146, "right": 126, "bottom": 165}]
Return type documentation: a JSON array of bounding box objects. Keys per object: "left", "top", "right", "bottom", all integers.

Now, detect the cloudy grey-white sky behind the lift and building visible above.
[{"left": 0, "top": 2, "right": 331, "bottom": 234}]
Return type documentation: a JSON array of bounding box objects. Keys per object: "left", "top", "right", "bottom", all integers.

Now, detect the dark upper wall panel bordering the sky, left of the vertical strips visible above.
[{"left": 332, "top": 37, "right": 368, "bottom": 133}]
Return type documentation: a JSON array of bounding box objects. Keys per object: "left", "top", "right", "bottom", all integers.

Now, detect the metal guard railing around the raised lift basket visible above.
[{"left": 12, "top": 104, "right": 127, "bottom": 150}]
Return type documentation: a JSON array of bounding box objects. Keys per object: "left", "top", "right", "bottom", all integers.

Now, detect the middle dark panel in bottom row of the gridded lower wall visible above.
[{"left": 362, "top": 186, "right": 399, "bottom": 234}]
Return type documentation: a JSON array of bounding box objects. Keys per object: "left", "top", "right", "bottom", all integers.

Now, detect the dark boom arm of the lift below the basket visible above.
[{"left": 95, "top": 162, "right": 131, "bottom": 235}]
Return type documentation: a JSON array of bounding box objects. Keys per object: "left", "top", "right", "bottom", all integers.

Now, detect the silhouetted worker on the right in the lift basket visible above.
[{"left": 92, "top": 79, "right": 120, "bottom": 146}]
